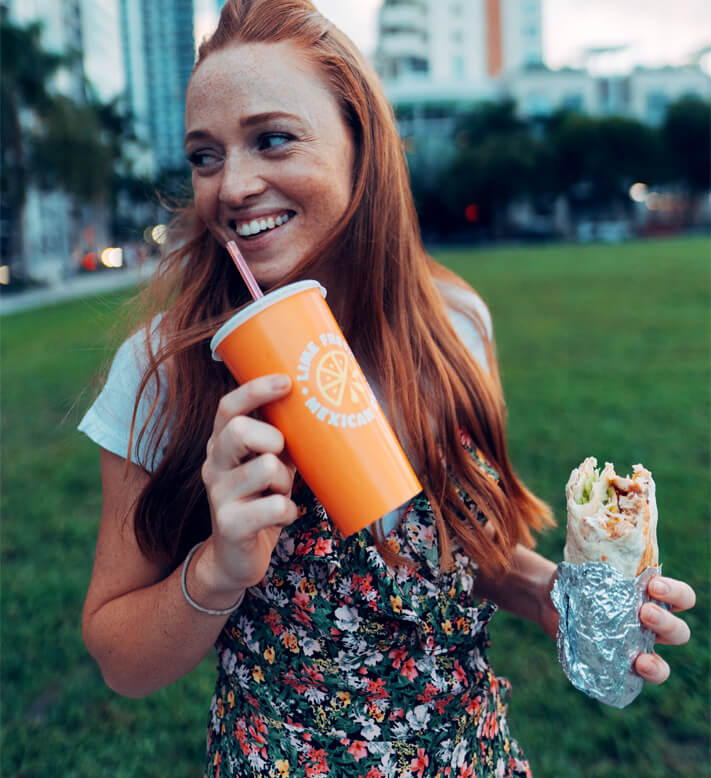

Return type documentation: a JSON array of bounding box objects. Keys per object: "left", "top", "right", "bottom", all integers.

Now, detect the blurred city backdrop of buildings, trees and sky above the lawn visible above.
[{"left": 0, "top": 0, "right": 711, "bottom": 278}]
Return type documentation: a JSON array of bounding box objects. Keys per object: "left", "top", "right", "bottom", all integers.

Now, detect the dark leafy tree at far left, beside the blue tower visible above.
[{"left": 1, "top": 13, "right": 143, "bottom": 278}]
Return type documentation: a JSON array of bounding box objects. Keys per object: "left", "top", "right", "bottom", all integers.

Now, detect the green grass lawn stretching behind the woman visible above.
[{"left": 0, "top": 238, "right": 711, "bottom": 778}]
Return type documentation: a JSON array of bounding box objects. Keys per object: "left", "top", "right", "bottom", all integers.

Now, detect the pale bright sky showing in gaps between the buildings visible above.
[{"left": 195, "top": 0, "right": 711, "bottom": 72}]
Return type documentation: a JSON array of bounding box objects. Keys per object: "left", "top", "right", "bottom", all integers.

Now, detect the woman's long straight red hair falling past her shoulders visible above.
[{"left": 125, "top": 0, "right": 553, "bottom": 573}]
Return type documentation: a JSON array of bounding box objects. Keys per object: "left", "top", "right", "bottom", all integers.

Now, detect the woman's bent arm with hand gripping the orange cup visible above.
[{"left": 82, "top": 378, "right": 297, "bottom": 697}]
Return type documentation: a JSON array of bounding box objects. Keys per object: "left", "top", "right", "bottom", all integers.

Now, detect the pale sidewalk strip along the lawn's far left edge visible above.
[{"left": 0, "top": 260, "right": 157, "bottom": 316}]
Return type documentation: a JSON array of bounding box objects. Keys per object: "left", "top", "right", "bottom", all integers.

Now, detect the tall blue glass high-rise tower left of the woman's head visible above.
[{"left": 121, "top": 0, "right": 195, "bottom": 171}]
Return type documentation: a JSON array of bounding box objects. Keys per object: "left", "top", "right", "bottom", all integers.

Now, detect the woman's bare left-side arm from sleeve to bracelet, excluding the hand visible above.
[{"left": 82, "top": 449, "right": 234, "bottom": 697}]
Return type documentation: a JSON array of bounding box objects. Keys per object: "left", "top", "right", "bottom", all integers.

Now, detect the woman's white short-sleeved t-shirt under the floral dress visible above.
[{"left": 78, "top": 286, "right": 491, "bottom": 533}]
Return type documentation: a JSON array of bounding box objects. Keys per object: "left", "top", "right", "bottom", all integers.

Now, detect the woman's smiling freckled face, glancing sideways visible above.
[{"left": 185, "top": 42, "right": 354, "bottom": 286}]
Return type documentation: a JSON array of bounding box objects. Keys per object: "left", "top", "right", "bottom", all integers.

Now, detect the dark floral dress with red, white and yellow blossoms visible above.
[{"left": 205, "top": 437, "right": 531, "bottom": 778}]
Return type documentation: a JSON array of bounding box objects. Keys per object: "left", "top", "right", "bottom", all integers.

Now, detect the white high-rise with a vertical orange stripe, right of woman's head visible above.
[{"left": 376, "top": 0, "right": 543, "bottom": 104}]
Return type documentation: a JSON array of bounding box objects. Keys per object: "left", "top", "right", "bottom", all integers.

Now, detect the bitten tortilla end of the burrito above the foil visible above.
[{"left": 563, "top": 457, "right": 659, "bottom": 578}]
